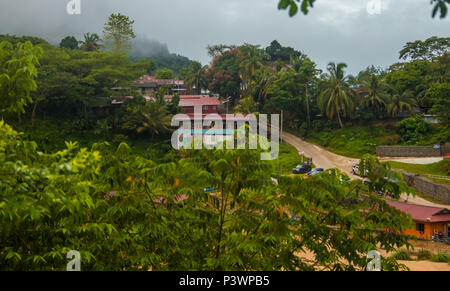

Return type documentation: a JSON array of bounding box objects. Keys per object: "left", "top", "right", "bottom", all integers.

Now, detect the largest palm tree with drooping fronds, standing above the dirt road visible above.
[{"left": 318, "top": 63, "right": 353, "bottom": 128}]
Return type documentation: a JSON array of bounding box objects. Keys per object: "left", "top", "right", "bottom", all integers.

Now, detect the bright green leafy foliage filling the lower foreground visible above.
[{"left": 0, "top": 122, "right": 414, "bottom": 270}]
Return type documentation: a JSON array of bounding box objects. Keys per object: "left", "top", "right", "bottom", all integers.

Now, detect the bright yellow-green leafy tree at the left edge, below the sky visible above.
[{"left": 0, "top": 41, "right": 42, "bottom": 121}]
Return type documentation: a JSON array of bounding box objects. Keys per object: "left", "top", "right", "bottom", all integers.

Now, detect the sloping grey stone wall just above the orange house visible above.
[{"left": 402, "top": 172, "right": 450, "bottom": 204}]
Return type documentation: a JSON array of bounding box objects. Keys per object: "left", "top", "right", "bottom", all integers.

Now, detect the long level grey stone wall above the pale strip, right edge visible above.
[{"left": 377, "top": 146, "right": 450, "bottom": 157}]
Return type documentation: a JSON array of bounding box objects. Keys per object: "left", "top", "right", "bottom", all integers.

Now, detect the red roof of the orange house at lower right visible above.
[{"left": 387, "top": 201, "right": 450, "bottom": 222}]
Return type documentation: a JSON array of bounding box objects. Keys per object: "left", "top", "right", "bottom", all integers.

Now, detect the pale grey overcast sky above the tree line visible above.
[{"left": 0, "top": 0, "right": 450, "bottom": 73}]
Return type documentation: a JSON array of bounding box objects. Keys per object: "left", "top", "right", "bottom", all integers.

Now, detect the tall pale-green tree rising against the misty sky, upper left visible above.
[{"left": 103, "top": 13, "right": 136, "bottom": 52}]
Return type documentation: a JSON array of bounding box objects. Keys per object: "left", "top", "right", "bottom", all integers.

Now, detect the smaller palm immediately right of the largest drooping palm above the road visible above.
[{"left": 361, "top": 74, "right": 388, "bottom": 110}]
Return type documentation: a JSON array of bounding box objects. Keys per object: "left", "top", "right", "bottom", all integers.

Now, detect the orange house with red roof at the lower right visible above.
[{"left": 387, "top": 201, "right": 450, "bottom": 240}]
